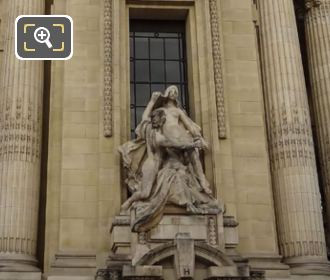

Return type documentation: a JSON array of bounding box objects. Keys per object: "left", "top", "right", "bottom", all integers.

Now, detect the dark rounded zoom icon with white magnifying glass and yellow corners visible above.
[{"left": 15, "top": 15, "right": 73, "bottom": 60}]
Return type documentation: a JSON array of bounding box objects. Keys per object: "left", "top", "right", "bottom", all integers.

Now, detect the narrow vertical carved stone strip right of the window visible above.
[{"left": 209, "top": 0, "right": 226, "bottom": 139}]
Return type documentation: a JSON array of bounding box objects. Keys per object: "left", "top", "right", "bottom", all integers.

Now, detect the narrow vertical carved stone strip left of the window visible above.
[{"left": 103, "top": 0, "right": 112, "bottom": 137}]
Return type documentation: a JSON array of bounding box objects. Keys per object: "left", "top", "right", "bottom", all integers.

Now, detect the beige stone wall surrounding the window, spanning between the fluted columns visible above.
[{"left": 45, "top": 0, "right": 278, "bottom": 276}]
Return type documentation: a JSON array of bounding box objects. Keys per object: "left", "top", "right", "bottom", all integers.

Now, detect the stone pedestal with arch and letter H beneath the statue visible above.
[{"left": 104, "top": 211, "right": 250, "bottom": 279}]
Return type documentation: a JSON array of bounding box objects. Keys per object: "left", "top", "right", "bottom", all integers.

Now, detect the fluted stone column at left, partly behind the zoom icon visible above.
[{"left": 0, "top": 0, "right": 44, "bottom": 272}]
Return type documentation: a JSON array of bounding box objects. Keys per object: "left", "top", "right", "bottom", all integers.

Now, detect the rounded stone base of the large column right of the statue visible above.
[{"left": 284, "top": 256, "right": 330, "bottom": 275}]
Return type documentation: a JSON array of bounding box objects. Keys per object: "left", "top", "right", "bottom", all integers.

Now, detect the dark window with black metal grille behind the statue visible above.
[{"left": 130, "top": 20, "right": 189, "bottom": 138}]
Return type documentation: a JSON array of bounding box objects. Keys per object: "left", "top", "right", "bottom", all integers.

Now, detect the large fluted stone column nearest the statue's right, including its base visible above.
[{"left": 259, "top": 0, "right": 329, "bottom": 274}]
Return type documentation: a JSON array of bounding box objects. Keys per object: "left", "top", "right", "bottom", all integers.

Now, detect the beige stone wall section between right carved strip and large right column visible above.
[{"left": 218, "top": 0, "right": 277, "bottom": 254}]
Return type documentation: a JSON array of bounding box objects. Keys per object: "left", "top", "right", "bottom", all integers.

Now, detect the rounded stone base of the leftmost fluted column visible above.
[{"left": 0, "top": 253, "right": 40, "bottom": 272}]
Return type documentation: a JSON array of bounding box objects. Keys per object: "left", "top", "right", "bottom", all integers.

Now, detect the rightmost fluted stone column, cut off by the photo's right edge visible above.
[{"left": 305, "top": 0, "right": 330, "bottom": 245}]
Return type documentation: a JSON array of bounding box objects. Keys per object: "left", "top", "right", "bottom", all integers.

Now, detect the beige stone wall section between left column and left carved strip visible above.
[{"left": 45, "top": 0, "right": 103, "bottom": 271}]
